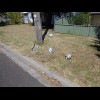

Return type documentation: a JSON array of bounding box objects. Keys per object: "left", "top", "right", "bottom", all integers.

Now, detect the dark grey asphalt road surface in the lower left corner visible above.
[{"left": 0, "top": 53, "right": 44, "bottom": 87}]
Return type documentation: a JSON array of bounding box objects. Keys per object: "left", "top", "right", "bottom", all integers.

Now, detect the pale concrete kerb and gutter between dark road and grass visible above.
[{"left": 0, "top": 43, "right": 80, "bottom": 87}]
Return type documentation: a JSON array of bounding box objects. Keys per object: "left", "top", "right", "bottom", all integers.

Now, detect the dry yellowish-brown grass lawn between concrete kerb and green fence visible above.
[{"left": 0, "top": 25, "right": 100, "bottom": 86}]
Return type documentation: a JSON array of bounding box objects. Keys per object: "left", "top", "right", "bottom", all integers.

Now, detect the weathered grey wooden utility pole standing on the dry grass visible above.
[{"left": 33, "top": 12, "right": 43, "bottom": 43}]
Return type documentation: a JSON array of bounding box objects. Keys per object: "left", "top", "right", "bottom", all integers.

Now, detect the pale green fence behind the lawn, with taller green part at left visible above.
[{"left": 54, "top": 18, "right": 100, "bottom": 37}]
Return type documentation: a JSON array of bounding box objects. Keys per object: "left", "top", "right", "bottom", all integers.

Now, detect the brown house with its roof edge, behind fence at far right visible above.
[{"left": 90, "top": 12, "right": 100, "bottom": 26}]
